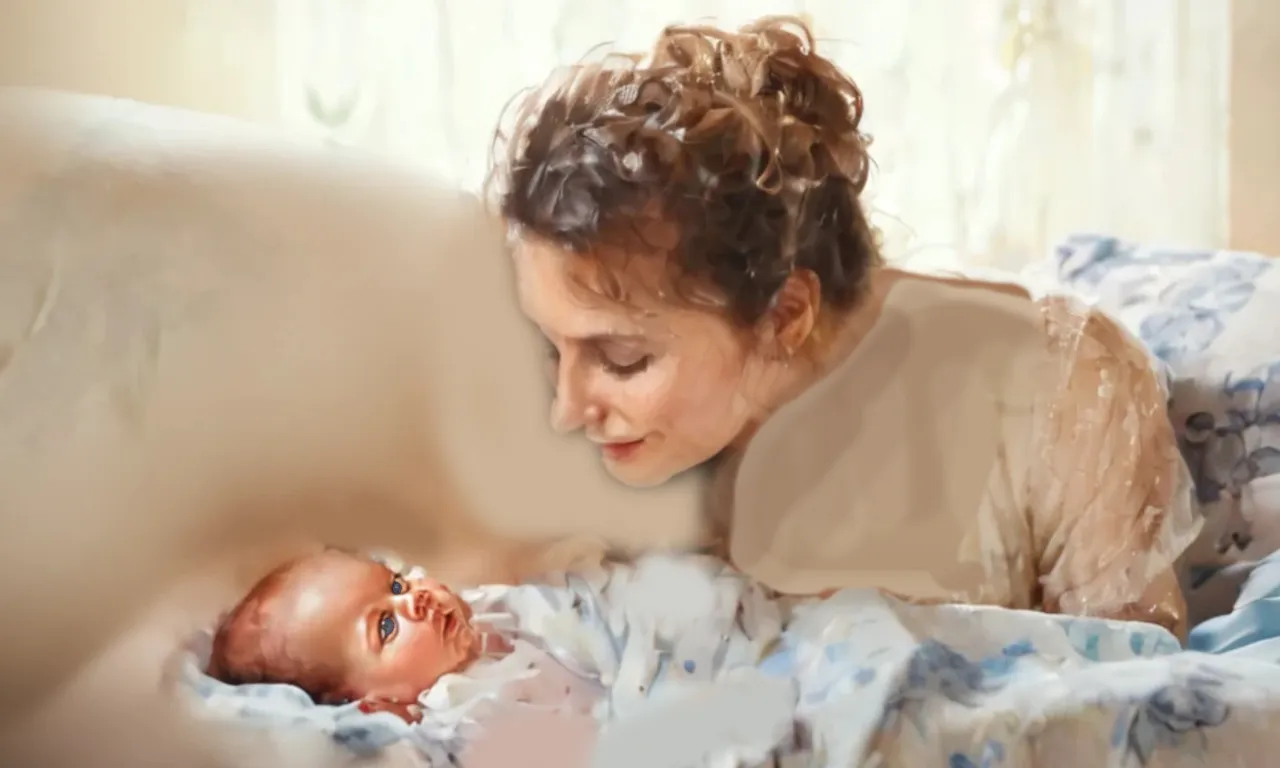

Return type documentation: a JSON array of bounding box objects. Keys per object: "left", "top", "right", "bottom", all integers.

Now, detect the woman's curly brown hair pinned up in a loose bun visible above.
[{"left": 486, "top": 17, "right": 881, "bottom": 326}]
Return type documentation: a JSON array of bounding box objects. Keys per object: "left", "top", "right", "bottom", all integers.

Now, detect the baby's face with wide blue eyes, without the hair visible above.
[{"left": 266, "top": 552, "right": 480, "bottom": 701}]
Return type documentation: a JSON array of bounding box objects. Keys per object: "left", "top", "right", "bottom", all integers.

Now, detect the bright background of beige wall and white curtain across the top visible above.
[{"left": 0, "top": 0, "right": 1280, "bottom": 259}]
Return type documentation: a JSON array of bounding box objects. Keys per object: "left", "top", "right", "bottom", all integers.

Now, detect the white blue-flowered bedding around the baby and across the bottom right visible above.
[{"left": 177, "top": 559, "right": 1280, "bottom": 768}]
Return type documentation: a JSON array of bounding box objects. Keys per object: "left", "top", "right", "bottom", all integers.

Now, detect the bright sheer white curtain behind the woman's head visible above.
[{"left": 276, "top": 0, "right": 1230, "bottom": 269}]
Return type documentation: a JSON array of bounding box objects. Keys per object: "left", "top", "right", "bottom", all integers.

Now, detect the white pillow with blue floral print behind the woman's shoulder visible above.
[{"left": 1052, "top": 234, "right": 1280, "bottom": 604}]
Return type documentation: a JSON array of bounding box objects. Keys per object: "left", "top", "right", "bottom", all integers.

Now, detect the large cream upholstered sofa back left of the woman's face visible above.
[{"left": 0, "top": 91, "right": 696, "bottom": 762}]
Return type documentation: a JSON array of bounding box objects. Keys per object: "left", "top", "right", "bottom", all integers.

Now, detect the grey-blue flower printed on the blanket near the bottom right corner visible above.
[{"left": 1114, "top": 668, "right": 1231, "bottom": 765}]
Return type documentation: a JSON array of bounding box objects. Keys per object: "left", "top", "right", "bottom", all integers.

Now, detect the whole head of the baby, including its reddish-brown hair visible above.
[{"left": 209, "top": 549, "right": 480, "bottom": 704}]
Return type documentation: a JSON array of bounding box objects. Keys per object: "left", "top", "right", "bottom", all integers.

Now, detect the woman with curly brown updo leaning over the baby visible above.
[{"left": 490, "top": 18, "right": 1199, "bottom": 634}]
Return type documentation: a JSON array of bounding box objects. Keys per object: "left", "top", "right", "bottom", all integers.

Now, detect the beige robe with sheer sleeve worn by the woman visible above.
[{"left": 730, "top": 275, "right": 1201, "bottom": 632}]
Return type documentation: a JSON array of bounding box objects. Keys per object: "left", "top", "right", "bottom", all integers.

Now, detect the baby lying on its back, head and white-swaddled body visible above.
[{"left": 207, "top": 549, "right": 781, "bottom": 737}]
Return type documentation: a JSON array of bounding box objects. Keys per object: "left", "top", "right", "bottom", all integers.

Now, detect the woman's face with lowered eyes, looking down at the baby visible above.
[{"left": 516, "top": 242, "right": 765, "bottom": 486}]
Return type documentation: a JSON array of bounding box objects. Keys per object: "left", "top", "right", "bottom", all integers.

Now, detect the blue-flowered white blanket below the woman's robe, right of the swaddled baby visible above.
[{"left": 788, "top": 591, "right": 1280, "bottom": 768}]
